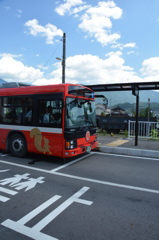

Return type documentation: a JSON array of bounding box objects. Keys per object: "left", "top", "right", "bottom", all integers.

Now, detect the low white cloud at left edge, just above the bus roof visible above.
[{"left": 0, "top": 56, "right": 43, "bottom": 82}]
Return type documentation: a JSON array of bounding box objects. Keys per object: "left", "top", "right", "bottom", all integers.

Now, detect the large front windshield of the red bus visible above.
[{"left": 65, "top": 98, "right": 96, "bottom": 129}]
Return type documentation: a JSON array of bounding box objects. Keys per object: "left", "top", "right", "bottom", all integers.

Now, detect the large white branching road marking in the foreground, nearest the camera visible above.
[{"left": 1, "top": 187, "right": 93, "bottom": 240}]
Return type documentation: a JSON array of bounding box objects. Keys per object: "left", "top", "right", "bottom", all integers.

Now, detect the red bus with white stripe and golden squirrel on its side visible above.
[{"left": 0, "top": 84, "right": 98, "bottom": 158}]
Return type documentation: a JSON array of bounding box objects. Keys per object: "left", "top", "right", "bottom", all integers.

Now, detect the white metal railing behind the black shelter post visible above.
[{"left": 128, "top": 120, "right": 159, "bottom": 139}]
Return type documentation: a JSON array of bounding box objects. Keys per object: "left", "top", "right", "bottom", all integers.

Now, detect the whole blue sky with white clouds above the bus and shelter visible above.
[{"left": 0, "top": 0, "right": 159, "bottom": 85}]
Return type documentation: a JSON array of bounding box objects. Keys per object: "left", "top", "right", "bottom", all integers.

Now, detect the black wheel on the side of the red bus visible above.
[{"left": 9, "top": 133, "right": 27, "bottom": 158}]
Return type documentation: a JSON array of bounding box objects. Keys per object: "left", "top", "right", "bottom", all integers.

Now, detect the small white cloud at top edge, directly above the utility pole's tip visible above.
[{"left": 55, "top": 0, "right": 87, "bottom": 16}]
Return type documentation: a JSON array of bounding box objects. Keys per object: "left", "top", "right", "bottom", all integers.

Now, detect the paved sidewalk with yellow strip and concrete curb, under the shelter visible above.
[{"left": 98, "top": 135, "right": 159, "bottom": 158}]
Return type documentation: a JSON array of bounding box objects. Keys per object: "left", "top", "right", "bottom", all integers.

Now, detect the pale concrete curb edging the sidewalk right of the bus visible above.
[{"left": 97, "top": 146, "right": 159, "bottom": 158}]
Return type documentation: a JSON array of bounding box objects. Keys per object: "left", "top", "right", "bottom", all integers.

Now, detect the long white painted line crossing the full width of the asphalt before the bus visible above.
[{"left": 0, "top": 160, "right": 159, "bottom": 194}]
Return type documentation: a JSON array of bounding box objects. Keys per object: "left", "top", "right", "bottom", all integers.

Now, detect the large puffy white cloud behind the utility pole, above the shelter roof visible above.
[{"left": 49, "top": 52, "right": 141, "bottom": 85}]
